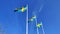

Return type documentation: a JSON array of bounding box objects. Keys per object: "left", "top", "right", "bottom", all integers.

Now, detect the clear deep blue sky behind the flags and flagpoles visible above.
[{"left": 0, "top": 0, "right": 60, "bottom": 34}]
